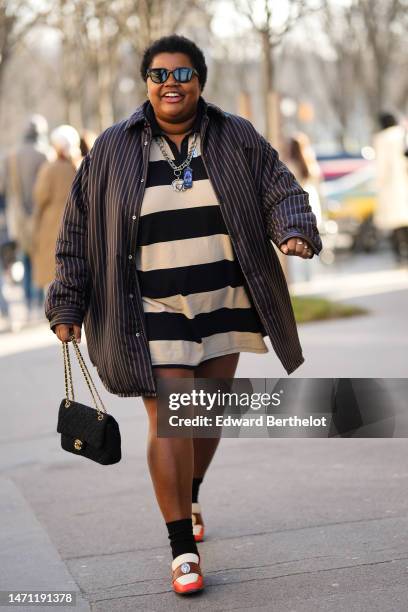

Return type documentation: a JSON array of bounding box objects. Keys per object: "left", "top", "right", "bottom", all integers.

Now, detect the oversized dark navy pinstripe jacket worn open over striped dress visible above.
[{"left": 45, "top": 98, "right": 322, "bottom": 397}]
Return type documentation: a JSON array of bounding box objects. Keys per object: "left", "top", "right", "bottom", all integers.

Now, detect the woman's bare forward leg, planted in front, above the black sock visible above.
[{"left": 143, "top": 368, "right": 194, "bottom": 523}]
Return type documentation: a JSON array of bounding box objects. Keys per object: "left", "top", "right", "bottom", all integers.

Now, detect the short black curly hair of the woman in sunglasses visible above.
[{"left": 140, "top": 34, "right": 207, "bottom": 89}]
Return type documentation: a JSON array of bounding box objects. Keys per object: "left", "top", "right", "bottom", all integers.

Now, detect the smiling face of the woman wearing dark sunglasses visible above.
[{"left": 147, "top": 53, "right": 201, "bottom": 123}]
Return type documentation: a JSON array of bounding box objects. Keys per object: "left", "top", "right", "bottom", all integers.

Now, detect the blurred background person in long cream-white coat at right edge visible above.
[{"left": 374, "top": 113, "right": 408, "bottom": 262}]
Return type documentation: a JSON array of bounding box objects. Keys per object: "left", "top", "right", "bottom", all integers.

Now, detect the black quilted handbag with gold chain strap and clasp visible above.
[{"left": 57, "top": 335, "right": 122, "bottom": 465}]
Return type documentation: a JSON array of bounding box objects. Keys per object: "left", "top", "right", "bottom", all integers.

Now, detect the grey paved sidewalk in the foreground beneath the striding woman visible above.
[{"left": 0, "top": 338, "right": 408, "bottom": 612}]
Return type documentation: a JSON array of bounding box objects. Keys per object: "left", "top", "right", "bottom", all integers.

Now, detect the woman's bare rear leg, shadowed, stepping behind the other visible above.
[{"left": 193, "top": 353, "right": 239, "bottom": 478}]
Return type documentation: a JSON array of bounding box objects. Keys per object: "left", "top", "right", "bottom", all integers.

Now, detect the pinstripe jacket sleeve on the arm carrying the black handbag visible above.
[{"left": 45, "top": 154, "right": 90, "bottom": 332}]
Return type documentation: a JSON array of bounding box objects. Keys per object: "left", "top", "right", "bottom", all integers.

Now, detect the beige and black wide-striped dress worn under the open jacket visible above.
[{"left": 136, "top": 101, "right": 269, "bottom": 368}]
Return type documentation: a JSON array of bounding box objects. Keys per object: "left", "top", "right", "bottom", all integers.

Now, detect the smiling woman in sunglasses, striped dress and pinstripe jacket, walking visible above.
[{"left": 46, "top": 35, "right": 321, "bottom": 594}]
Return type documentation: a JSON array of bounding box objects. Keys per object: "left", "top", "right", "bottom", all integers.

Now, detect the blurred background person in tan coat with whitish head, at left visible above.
[{"left": 32, "top": 125, "right": 80, "bottom": 288}]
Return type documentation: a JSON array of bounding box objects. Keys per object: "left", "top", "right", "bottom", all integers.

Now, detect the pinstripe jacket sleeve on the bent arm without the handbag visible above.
[{"left": 260, "top": 136, "right": 322, "bottom": 255}]
